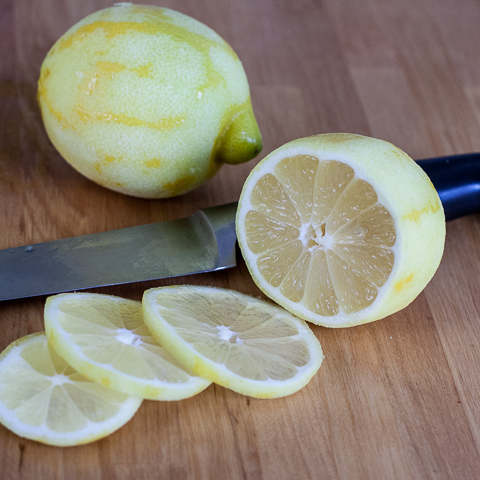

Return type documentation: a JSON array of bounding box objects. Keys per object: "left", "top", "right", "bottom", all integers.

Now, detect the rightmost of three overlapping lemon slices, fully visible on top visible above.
[{"left": 142, "top": 286, "right": 323, "bottom": 398}]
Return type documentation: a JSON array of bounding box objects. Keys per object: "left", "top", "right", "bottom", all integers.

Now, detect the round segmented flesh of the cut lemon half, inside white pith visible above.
[{"left": 245, "top": 155, "right": 396, "bottom": 316}]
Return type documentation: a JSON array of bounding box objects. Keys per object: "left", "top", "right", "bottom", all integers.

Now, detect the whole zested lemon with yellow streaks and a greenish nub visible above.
[{"left": 38, "top": 3, "right": 262, "bottom": 198}]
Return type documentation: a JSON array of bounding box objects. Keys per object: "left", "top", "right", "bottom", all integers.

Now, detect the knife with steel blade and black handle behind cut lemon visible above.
[{"left": 0, "top": 153, "right": 480, "bottom": 301}]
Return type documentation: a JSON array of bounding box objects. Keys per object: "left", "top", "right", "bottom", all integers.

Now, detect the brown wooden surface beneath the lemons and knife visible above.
[{"left": 0, "top": 0, "right": 480, "bottom": 480}]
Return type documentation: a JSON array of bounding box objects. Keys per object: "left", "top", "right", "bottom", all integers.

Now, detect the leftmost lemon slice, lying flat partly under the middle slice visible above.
[{"left": 0, "top": 332, "right": 142, "bottom": 446}]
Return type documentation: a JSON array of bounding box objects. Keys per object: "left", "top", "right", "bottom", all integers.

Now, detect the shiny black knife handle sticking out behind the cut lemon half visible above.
[{"left": 417, "top": 153, "right": 480, "bottom": 221}]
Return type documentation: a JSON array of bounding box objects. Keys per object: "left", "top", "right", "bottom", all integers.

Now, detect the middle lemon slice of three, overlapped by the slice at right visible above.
[{"left": 45, "top": 293, "right": 210, "bottom": 400}]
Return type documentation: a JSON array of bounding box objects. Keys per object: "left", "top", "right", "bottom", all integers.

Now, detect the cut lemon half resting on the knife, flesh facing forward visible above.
[{"left": 236, "top": 133, "right": 445, "bottom": 327}]
